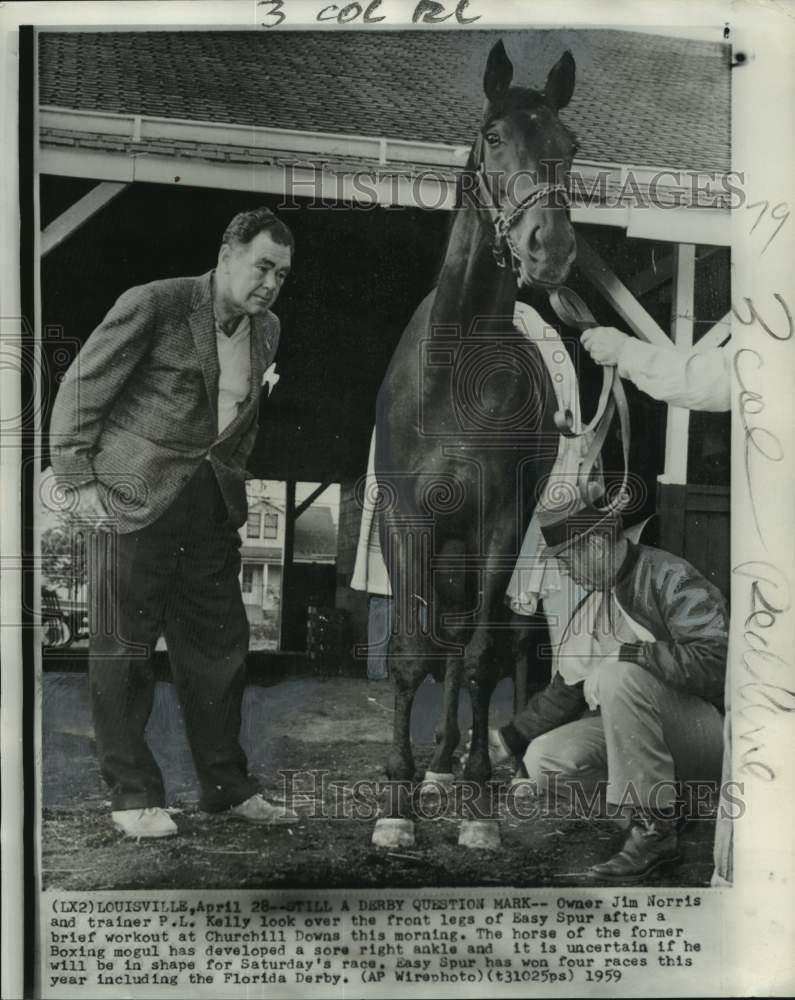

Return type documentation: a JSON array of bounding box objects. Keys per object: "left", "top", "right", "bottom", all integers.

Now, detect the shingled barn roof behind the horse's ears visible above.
[{"left": 39, "top": 30, "right": 730, "bottom": 172}]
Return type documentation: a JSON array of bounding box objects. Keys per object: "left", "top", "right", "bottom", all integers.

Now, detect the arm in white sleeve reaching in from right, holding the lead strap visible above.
[{"left": 582, "top": 327, "right": 731, "bottom": 412}]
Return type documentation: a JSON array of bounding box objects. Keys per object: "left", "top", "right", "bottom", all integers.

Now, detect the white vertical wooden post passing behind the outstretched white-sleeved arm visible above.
[{"left": 664, "top": 243, "right": 696, "bottom": 485}]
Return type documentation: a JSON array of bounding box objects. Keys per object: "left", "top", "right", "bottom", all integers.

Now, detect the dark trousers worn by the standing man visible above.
[{"left": 90, "top": 461, "right": 258, "bottom": 812}]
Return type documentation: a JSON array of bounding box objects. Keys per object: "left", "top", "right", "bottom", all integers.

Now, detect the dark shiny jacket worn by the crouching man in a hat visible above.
[{"left": 500, "top": 542, "right": 729, "bottom": 754}]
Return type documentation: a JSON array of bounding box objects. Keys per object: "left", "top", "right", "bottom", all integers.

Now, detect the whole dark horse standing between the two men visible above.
[{"left": 373, "top": 42, "right": 576, "bottom": 847}]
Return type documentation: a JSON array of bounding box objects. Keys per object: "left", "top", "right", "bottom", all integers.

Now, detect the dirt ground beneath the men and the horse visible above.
[{"left": 41, "top": 677, "right": 714, "bottom": 890}]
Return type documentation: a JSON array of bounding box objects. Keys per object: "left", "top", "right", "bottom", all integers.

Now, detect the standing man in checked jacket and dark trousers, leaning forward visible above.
[{"left": 50, "top": 208, "right": 296, "bottom": 837}]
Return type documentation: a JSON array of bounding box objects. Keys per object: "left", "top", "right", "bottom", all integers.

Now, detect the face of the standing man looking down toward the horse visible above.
[{"left": 218, "top": 233, "right": 292, "bottom": 316}]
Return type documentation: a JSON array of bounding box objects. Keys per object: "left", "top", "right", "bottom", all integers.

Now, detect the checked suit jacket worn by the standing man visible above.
[{"left": 50, "top": 271, "right": 279, "bottom": 532}]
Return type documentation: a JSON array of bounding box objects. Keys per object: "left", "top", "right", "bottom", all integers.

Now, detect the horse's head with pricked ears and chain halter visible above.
[{"left": 475, "top": 42, "right": 577, "bottom": 286}]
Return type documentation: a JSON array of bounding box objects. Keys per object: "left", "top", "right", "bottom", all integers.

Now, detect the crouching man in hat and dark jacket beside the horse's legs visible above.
[{"left": 490, "top": 501, "right": 728, "bottom": 882}]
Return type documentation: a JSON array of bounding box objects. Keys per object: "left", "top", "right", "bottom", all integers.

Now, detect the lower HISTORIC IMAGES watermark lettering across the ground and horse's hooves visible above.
[{"left": 278, "top": 770, "right": 745, "bottom": 822}]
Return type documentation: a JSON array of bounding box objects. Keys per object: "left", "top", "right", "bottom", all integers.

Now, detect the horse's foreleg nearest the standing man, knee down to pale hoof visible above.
[{"left": 372, "top": 636, "right": 427, "bottom": 849}]
